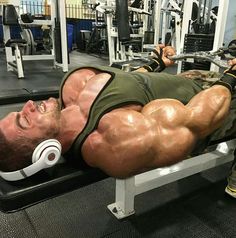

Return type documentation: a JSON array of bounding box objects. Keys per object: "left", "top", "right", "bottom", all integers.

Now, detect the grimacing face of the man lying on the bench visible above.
[{"left": 0, "top": 98, "right": 60, "bottom": 141}]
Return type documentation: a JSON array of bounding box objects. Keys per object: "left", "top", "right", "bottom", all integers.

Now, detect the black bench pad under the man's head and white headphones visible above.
[{"left": 0, "top": 162, "right": 108, "bottom": 213}]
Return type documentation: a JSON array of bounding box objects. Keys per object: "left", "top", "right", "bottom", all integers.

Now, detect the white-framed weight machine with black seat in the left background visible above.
[{"left": 0, "top": 0, "right": 68, "bottom": 78}]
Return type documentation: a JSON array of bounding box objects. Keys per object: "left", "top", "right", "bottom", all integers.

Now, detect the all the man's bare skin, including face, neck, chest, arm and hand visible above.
[{"left": 0, "top": 47, "right": 230, "bottom": 178}]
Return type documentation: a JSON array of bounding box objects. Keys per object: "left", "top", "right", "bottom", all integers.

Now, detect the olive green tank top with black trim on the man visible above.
[{"left": 60, "top": 66, "right": 202, "bottom": 158}]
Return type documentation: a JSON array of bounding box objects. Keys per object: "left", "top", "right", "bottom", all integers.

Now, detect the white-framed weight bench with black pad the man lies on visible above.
[{"left": 0, "top": 139, "right": 236, "bottom": 215}]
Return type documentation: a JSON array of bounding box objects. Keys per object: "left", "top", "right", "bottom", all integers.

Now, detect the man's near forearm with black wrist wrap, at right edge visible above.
[{"left": 187, "top": 61, "right": 236, "bottom": 136}]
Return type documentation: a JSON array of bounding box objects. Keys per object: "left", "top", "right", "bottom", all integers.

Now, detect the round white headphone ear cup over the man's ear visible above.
[{"left": 32, "top": 139, "right": 61, "bottom": 169}]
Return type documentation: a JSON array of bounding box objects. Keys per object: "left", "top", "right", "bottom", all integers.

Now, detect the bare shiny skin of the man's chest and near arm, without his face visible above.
[{"left": 62, "top": 69, "right": 231, "bottom": 178}]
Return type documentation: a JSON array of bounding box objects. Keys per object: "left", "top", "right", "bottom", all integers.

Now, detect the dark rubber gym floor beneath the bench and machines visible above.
[{"left": 0, "top": 51, "right": 236, "bottom": 238}]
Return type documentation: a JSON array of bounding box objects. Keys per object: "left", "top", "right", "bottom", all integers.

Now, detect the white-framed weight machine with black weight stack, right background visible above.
[{"left": 144, "top": 0, "right": 228, "bottom": 72}]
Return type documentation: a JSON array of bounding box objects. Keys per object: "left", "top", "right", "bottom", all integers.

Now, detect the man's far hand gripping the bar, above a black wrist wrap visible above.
[{"left": 153, "top": 44, "right": 176, "bottom": 67}]
